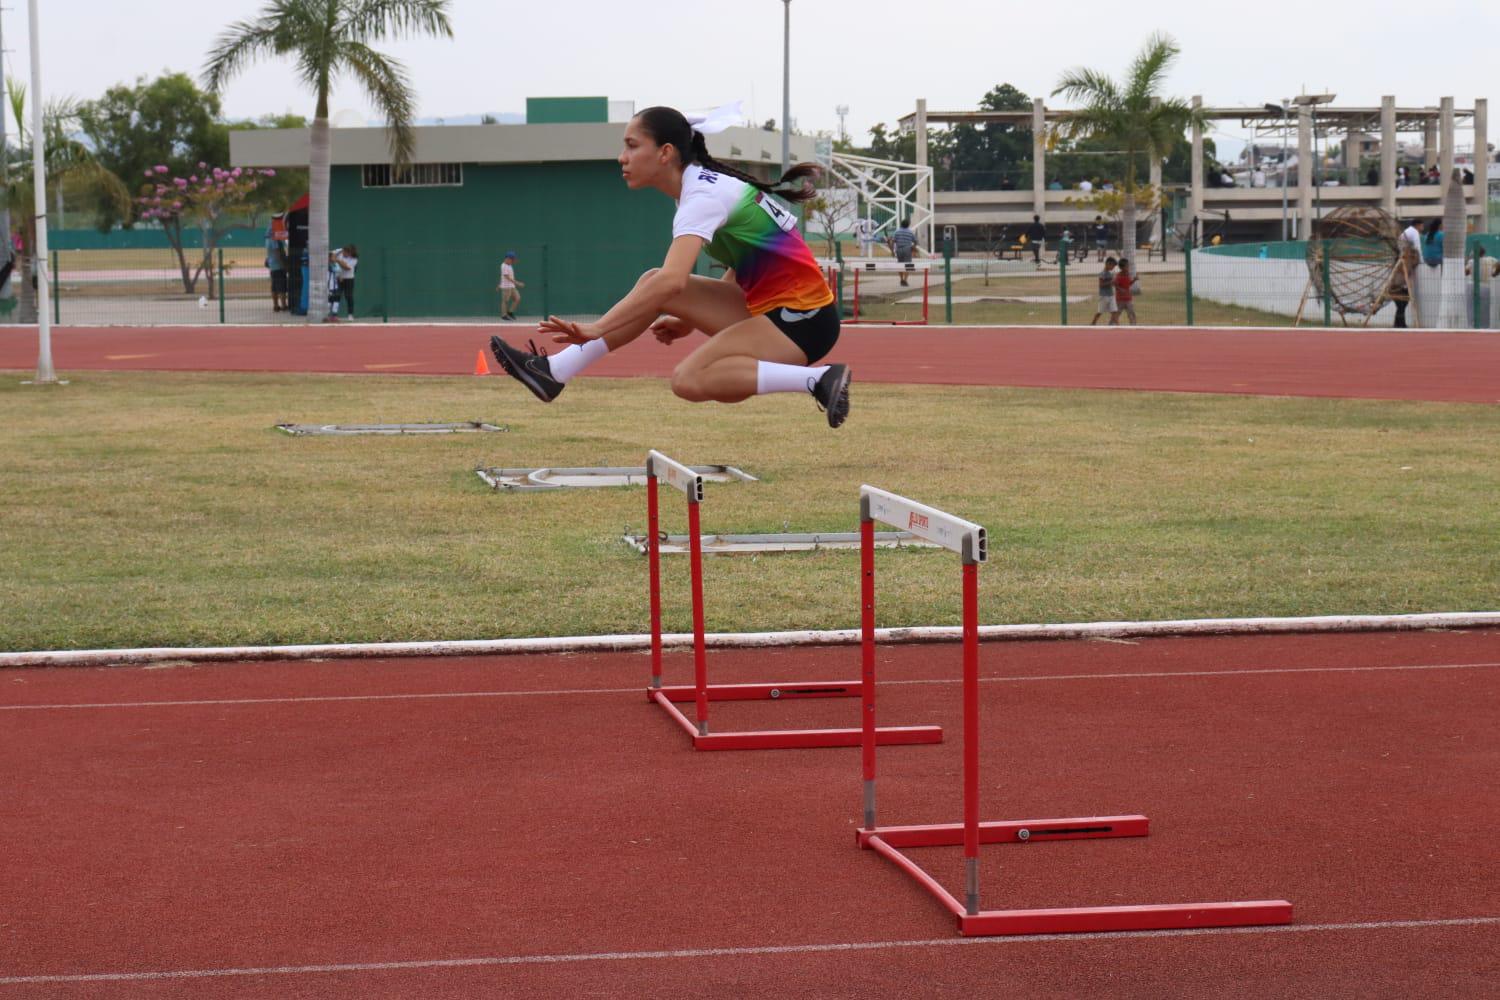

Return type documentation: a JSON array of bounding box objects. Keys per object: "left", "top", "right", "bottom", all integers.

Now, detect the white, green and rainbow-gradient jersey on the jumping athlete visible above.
[{"left": 672, "top": 163, "right": 834, "bottom": 316}]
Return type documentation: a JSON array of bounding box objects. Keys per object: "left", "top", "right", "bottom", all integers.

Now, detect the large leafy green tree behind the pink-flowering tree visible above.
[{"left": 78, "top": 73, "right": 230, "bottom": 229}]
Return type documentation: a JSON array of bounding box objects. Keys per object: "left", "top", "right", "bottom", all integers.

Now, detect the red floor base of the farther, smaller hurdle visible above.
[{"left": 647, "top": 682, "right": 942, "bottom": 750}]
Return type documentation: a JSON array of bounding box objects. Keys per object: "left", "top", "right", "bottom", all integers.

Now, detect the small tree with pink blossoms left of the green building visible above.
[{"left": 135, "top": 163, "right": 276, "bottom": 294}]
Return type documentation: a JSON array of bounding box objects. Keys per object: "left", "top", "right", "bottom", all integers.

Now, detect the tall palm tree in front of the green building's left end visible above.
[{"left": 203, "top": 0, "right": 453, "bottom": 321}]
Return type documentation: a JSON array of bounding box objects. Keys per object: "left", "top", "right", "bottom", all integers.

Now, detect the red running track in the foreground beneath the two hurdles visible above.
[{"left": 0, "top": 631, "right": 1500, "bottom": 997}]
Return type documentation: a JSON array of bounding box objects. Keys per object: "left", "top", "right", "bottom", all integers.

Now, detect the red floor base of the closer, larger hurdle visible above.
[{"left": 855, "top": 816, "right": 1292, "bottom": 937}]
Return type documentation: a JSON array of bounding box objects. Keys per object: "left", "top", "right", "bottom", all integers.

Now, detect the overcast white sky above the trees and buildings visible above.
[{"left": 11, "top": 0, "right": 1500, "bottom": 158}]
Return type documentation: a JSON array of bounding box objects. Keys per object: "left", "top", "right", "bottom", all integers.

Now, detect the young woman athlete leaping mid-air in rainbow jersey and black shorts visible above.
[{"left": 489, "top": 102, "right": 849, "bottom": 427}]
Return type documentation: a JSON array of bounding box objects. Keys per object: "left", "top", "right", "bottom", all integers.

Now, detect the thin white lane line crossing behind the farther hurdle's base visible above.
[{"left": 0, "top": 661, "right": 1500, "bottom": 712}]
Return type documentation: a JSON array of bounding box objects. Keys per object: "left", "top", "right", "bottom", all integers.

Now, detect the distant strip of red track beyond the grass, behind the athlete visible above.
[{"left": 0, "top": 325, "right": 1500, "bottom": 403}]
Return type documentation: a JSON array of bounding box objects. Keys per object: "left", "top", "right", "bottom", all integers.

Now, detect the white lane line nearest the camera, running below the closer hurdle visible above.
[{"left": 0, "top": 916, "right": 1500, "bottom": 987}]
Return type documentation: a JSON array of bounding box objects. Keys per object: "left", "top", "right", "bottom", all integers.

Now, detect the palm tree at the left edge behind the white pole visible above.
[{"left": 0, "top": 78, "right": 131, "bottom": 322}]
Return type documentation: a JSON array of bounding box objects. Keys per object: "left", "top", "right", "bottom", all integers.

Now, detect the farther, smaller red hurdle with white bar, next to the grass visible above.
[{"left": 647, "top": 451, "right": 942, "bottom": 750}]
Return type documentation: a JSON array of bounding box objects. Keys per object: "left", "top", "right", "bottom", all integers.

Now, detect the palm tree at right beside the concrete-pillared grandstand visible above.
[{"left": 1052, "top": 33, "right": 1208, "bottom": 260}]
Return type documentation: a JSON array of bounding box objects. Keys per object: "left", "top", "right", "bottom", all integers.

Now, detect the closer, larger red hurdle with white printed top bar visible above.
[{"left": 855, "top": 486, "right": 1292, "bottom": 936}]
